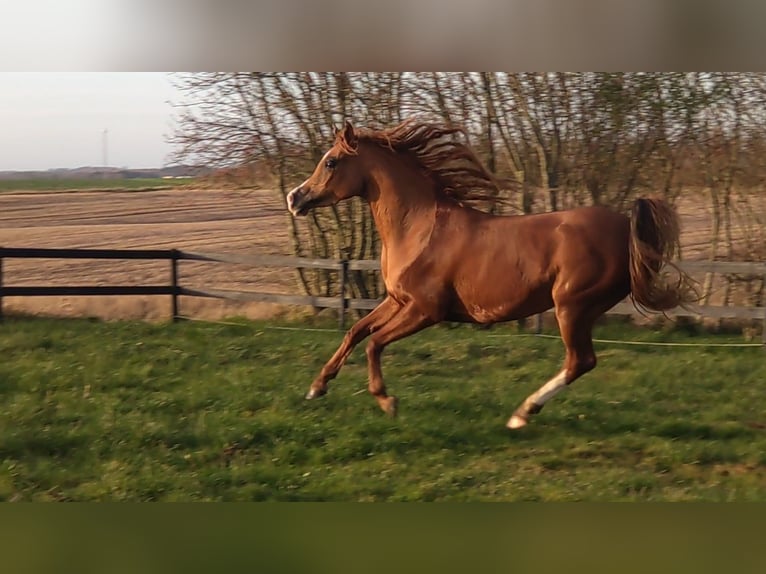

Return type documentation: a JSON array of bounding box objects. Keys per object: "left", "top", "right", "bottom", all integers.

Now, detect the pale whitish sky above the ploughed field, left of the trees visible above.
[{"left": 0, "top": 72, "right": 179, "bottom": 171}]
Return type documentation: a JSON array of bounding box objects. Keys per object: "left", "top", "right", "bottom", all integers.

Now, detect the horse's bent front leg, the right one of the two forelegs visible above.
[{"left": 366, "top": 304, "right": 437, "bottom": 417}]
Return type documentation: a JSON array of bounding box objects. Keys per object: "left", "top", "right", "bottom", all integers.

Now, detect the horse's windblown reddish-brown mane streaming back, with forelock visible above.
[{"left": 336, "top": 119, "right": 502, "bottom": 204}]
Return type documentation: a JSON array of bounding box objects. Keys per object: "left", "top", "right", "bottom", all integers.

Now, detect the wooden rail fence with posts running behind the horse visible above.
[{"left": 0, "top": 247, "right": 766, "bottom": 344}]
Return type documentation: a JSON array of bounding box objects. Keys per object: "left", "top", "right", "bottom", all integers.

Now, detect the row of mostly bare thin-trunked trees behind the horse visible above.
[{"left": 171, "top": 72, "right": 766, "bottom": 306}]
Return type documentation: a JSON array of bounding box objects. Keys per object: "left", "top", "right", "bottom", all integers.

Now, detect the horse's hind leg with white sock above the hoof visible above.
[{"left": 506, "top": 309, "right": 596, "bottom": 429}]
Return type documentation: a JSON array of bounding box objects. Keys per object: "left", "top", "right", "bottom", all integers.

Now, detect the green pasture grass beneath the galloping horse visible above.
[{"left": 0, "top": 318, "right": 766, "bottom": 501}]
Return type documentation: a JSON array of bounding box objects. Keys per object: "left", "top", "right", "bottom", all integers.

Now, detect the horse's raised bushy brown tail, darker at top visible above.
[{"left": 629, "top": 197, "right": 698, "bottom": 311}]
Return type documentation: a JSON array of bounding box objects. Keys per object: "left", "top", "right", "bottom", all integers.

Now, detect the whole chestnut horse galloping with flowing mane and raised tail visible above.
[{"left": 287, "top": 120, "right": 691, "bottom": 429}]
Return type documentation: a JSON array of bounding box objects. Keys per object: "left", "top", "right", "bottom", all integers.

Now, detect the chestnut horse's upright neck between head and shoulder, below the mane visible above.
[{"left": 367, "top": 148, "right": 437, "bottom": 250}]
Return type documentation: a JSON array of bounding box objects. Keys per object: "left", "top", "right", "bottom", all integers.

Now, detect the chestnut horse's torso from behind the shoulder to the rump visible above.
[{"left": 426, "top": 207, "right": 629, "bottom": 323}]
